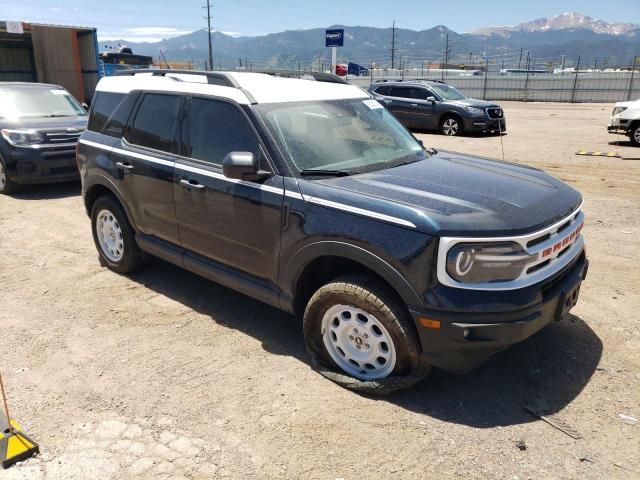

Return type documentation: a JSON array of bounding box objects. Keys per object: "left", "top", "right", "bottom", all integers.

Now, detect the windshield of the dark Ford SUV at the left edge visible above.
[{"left": 0, "top": 85, "right": 86, "bottom": 118}]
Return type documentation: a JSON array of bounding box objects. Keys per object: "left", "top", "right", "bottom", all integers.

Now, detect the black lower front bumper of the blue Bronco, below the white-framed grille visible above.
[{"left": 411, "top": 251, "right": 588, "bottom": 372}]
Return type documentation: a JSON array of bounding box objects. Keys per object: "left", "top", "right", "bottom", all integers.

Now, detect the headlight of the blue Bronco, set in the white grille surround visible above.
[{"left": 447, "top": 242, "right": 536, "bottom": 283}]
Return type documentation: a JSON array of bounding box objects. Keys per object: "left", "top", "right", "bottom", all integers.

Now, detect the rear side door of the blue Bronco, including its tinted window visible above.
[{"left": 112, "top": 93, "right": 183, "bottom": 244}]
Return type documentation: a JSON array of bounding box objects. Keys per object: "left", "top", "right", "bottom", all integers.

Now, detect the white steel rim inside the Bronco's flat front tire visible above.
[{"left": 321, "top": 305, "right": 397, "bottom": 380}]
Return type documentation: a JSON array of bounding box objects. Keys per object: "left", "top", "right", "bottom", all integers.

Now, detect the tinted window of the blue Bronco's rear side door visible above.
[{"left": 127, "top": 94, "right": 180, "bottom": 152}]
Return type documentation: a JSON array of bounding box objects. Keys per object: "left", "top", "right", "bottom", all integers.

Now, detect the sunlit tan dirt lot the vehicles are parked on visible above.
[{"left": 0, "top": 103, "right": 640, "bottom": 480}]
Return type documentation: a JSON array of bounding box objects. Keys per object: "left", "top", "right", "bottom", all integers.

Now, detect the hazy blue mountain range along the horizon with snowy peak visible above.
[{"left": 98, "top": 12, "right": 640, "bottom": 69}]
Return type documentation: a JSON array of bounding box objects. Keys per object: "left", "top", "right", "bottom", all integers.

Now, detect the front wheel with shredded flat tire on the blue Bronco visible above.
[{"left": 304, "top": 275, "right": 429, "bottom": 394}]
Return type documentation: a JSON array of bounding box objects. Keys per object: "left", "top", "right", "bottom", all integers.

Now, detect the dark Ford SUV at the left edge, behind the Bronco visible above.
[{"left": 0, "top": 82, "right": 87, "bottom": 193}]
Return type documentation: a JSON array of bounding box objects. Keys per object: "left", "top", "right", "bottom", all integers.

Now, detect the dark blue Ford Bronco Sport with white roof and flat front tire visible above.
[{"left": 78, "top": 71, "right": 587, "bottom": 393}]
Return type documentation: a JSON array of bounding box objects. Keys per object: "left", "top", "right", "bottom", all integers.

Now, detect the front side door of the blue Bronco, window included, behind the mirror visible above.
[{"left": 174, "top": 97, "right": 284, "bottom": 286}]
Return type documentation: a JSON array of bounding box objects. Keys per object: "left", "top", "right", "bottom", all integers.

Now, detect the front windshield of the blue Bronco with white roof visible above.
[{"left": 256, "top": 99, "right": 426, "bottom": 173}]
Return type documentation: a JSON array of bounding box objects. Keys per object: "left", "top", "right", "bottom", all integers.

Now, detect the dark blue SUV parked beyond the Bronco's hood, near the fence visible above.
[{"left": 369, "top": 80, "right": 507, "bottom": 135}]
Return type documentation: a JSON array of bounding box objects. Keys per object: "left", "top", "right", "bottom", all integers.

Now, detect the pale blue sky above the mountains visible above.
[{"left": 0, "top": 0, "right": 640, "bottom": 41}]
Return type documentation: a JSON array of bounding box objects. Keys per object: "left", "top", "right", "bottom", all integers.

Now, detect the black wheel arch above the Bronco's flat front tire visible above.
[{"left": 283, "top": 241, "right": 422, "bottom": 314}]
